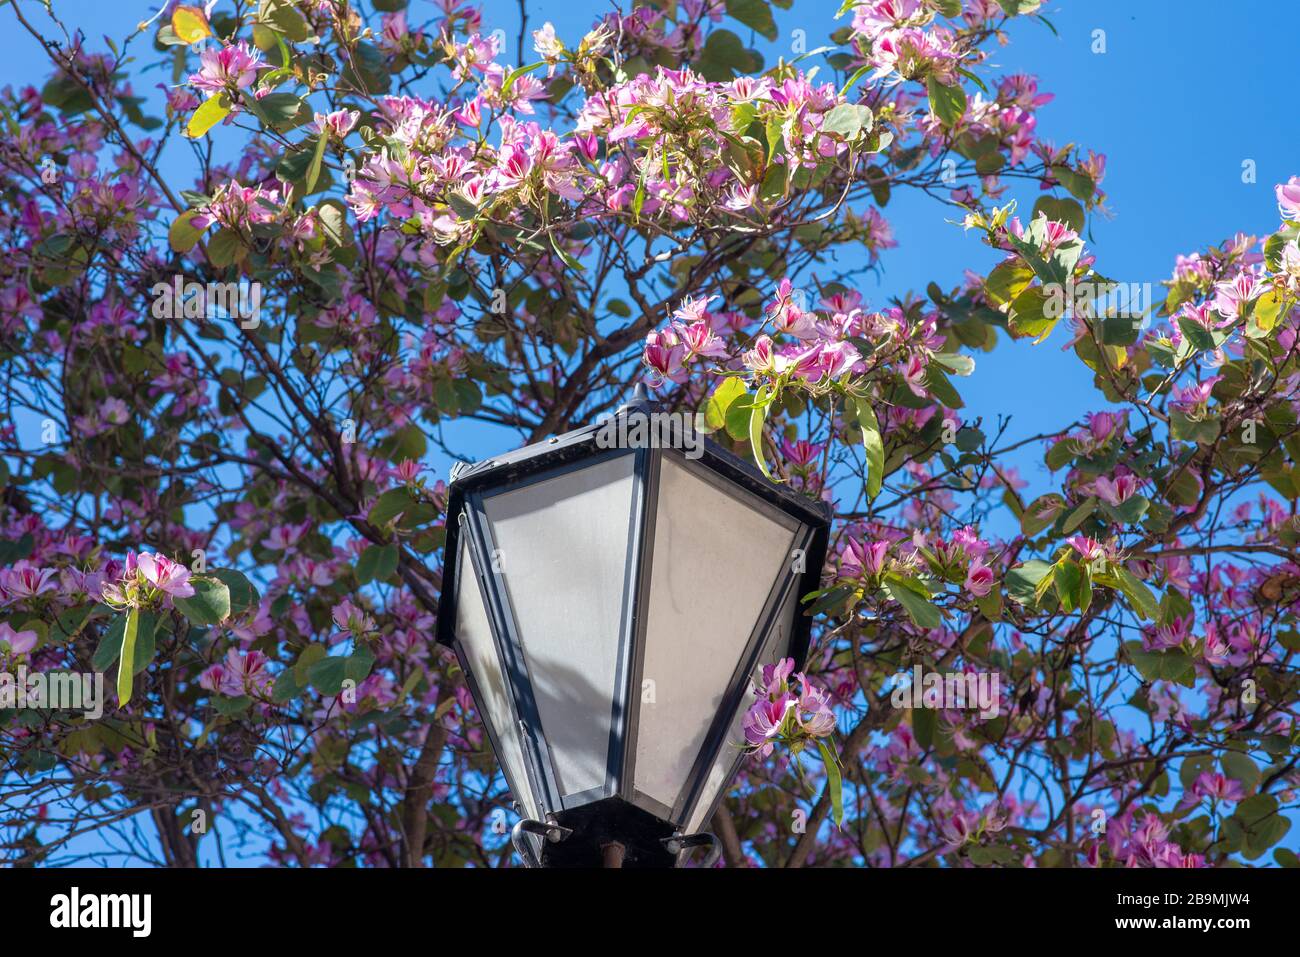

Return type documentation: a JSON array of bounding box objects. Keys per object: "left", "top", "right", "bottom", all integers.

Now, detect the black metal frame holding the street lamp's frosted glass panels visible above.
[{"left": 438, "top": 390, "right": 831, "bottom": 867}]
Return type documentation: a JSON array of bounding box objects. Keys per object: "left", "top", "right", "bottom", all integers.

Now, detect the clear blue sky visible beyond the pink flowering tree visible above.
[{"left": 0, "top": 0, "right": 1300, "bottom": 863}]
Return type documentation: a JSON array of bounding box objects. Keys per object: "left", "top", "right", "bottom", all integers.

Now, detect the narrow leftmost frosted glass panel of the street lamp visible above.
[{"left": 456, "top": 538, "right": 540, "bottom": 819}]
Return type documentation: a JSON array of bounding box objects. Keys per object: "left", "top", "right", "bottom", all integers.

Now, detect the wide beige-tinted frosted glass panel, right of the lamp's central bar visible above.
[{"left": 634, "top": 456, "right": 798, "bottom": 807}]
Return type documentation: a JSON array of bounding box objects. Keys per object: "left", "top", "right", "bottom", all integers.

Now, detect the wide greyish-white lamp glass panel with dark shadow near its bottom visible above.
[{"left": 484, "top": 454, "right": 636, "bottom": 794}]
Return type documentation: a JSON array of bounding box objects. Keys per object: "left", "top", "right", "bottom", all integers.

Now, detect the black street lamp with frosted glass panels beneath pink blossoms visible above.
[{"left": 438, "top": 389, "right": 829, "bottom": 867}]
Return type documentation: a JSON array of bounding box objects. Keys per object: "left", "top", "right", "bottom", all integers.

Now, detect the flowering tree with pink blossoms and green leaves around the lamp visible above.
[{"left": 0, "top": 0, "right": 1300, "bottom": 866}]
